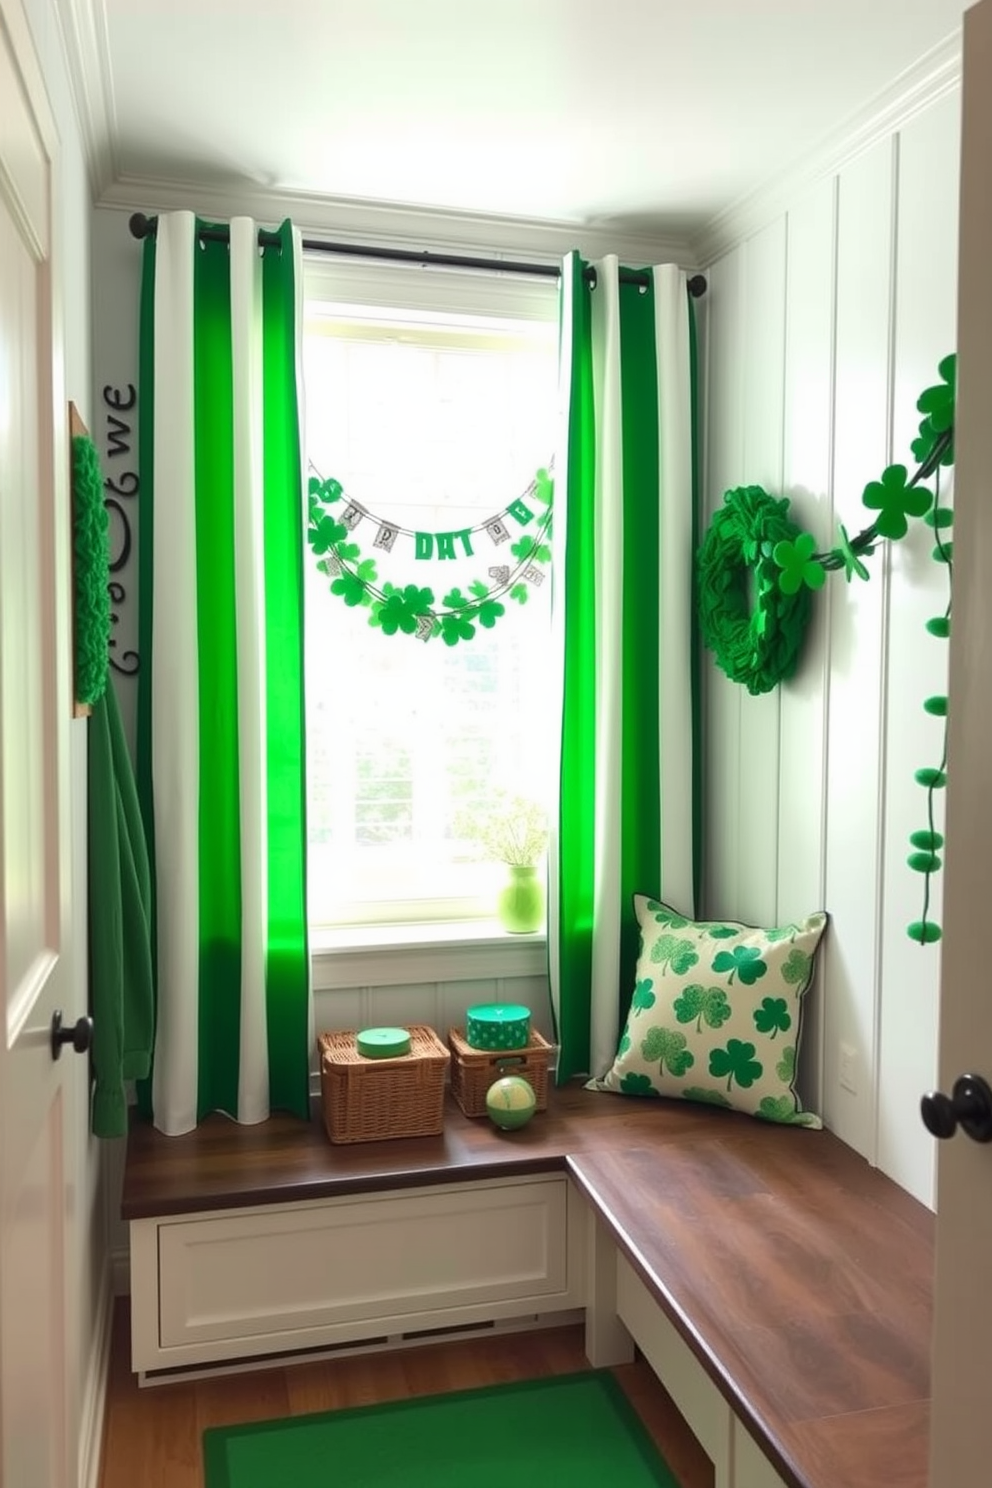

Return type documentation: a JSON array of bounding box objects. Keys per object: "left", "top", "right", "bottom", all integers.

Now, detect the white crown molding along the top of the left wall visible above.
[{"left": 54, "top": 0, "right": 117, "bottom": 201}]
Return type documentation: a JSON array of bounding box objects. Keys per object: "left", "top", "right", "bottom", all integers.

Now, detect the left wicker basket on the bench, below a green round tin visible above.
[{"left": 317, "top": 1024, "right": 451, "bottom": 1143}]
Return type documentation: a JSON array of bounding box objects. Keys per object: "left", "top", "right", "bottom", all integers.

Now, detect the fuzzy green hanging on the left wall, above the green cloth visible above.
[{"left": 71, "top": 434, "right": 110, "bottom": 704}]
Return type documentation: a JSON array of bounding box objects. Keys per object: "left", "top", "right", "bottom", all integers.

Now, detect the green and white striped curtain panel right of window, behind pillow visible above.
[{"left": 549, "top": 253, "right": 698, "bottom": 1083}]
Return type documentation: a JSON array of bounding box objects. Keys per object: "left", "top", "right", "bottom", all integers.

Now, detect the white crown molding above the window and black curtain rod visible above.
[{"left": 97, "top": 176, "right": 695, "bottom": 269}]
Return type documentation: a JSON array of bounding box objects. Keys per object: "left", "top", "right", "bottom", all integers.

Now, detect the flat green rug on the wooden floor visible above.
[{"left": 204, "top": 1370, "right": 678, "bottom": 1488}]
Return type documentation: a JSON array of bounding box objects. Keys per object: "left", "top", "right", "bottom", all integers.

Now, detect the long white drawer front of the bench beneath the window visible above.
[{"left": 158, "top": 1177, "right": 568, "bottom": 1348}]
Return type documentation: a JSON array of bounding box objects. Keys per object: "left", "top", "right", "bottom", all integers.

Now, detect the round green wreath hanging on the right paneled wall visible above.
[{"left": 696, "top": 485, "right": 824, "bottom": 695}]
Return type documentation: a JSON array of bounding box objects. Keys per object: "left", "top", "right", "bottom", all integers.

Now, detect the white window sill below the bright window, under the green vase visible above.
[{"left": 309, "top": 920, "right": 547, "bottom": 991}]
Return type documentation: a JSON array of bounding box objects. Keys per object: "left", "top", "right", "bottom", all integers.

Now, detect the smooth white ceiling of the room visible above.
[{"left": 71, "top": 0, "right": 964, "bottom": 249}]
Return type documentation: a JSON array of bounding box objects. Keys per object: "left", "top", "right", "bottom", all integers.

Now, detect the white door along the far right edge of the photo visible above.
[{"left": 930, "top": 0, "right": 992, "bottom": 1488}]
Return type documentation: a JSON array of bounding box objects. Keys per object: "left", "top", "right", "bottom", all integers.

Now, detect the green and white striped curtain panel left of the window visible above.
[{"left": 138, "top": 211, "right": 312, "bottom": 1134}]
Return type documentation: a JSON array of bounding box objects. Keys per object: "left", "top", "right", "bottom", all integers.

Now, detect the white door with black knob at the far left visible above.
[{"left": 0, "top": 0, "right": 76, "bottom": 1488}]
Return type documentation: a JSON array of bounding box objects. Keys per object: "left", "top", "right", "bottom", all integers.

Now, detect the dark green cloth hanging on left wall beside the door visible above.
[{"left": 88, "top": 682, "right": 155, "bottom": 1137}]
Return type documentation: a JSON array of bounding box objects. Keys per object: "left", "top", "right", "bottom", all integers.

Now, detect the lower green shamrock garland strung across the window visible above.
[{"left": 306, "top": 469, "right": 555, "bottom": 646}]
